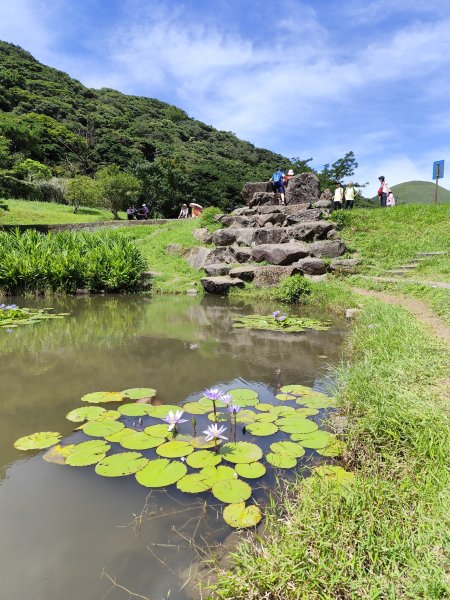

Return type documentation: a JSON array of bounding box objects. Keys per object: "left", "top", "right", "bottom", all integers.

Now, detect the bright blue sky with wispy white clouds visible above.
[{"left": 0, "top": 0, "right": 450, "bottom": 194}]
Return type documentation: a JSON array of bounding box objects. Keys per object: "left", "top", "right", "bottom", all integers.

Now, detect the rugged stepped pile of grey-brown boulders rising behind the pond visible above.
[{"left": 199, "top": 173, "right": 357, "bottom": 294}]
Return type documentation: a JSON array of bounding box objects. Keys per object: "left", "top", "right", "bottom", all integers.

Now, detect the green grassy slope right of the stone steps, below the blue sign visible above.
[{"left": 333, "top": 204, "right": 450, "bottom": 279}]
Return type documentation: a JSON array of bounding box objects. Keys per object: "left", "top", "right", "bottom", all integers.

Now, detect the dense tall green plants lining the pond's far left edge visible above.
[{"left": 0, "top": 230, "right": 146, "bottom": 294}]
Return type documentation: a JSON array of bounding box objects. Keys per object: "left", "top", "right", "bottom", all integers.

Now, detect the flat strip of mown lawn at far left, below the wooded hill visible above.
[{"left": 0, "top": 200, "right": 126, "bottom": 225}]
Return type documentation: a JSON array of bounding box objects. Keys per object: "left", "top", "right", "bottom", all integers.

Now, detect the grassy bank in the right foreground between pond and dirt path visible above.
[{"left": 213, "top": 301, "right": 450, "bottom": 600}]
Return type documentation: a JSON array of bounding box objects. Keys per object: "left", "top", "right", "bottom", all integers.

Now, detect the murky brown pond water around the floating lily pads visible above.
[{"left": 0, "top": 296, "right": 345, "bottom": 600}]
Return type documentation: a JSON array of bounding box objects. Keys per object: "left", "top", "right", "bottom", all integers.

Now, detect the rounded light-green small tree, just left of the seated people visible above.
[{"left": 95, "top": 165, "right": 141, "bottom": 219}]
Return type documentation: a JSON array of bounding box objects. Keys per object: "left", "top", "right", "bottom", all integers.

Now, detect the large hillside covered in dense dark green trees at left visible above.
[{"left": 0, "top": 41, "right": 290, "bottom": 214}]
